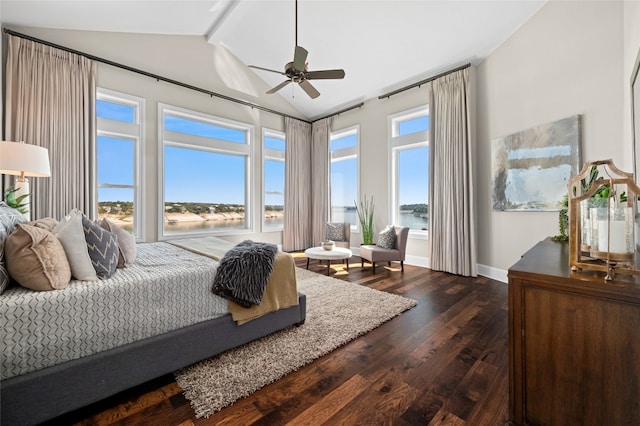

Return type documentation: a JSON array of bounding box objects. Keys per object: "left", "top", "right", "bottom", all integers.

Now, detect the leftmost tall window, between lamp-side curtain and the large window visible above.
[{"left": 96, "top": 88, "right": 144, "bottom": 240}]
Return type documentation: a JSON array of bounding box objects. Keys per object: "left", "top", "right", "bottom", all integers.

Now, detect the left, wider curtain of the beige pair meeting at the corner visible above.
[{"left": 282, "top": 117, "right": 313, "bottom": 251}]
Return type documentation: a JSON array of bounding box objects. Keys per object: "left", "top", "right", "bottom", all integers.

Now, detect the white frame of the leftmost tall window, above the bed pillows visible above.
[{"left": 95, "top": 87, "right": 145, "bottom": 241}]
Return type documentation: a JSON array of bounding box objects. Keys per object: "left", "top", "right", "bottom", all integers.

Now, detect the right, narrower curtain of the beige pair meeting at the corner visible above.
[{"left": 311, "top": 118, "right": 331, "bottom": 246}]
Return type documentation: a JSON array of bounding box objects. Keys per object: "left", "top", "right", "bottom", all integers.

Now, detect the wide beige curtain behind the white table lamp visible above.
[{"left": 4, "top": 35, "right": 97, "bottom": 219}]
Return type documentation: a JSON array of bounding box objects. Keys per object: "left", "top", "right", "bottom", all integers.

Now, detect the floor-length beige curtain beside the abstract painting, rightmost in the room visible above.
[{"left": 429, "top": 68, "right": 477, "bottom": 277}]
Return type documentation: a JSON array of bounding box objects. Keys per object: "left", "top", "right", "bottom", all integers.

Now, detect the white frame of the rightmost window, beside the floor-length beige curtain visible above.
[{"left": 388, "top": 105, "right": 429, "bottom": 239}]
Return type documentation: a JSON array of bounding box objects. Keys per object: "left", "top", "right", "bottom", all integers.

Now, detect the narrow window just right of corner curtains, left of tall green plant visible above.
[{"left": 329, "top": 126, "right": 359, "bottom": 230}]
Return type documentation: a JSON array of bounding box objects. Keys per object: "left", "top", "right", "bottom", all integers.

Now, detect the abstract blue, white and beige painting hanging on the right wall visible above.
[{"left": 491, "top": 115, "right": 580, "bottom": 211}]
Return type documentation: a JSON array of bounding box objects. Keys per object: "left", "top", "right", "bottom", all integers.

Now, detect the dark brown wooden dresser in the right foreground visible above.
[{"left": 509, "top": 240, "right": 640, "bottom": 426}]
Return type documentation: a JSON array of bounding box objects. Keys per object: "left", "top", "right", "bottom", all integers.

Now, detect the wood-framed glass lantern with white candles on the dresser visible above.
[{"left": 569, "top": 160, "right": 640, "bottom": 281}]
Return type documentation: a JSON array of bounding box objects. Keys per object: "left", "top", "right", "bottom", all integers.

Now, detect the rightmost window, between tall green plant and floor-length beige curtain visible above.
[{"left": 389, "top": 107, "right": 429, "bottom": 236}]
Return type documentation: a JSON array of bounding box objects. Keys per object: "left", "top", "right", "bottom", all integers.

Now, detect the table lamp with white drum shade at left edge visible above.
[{"left": 0, "top": 141, "right": 51, "bottom": 220}]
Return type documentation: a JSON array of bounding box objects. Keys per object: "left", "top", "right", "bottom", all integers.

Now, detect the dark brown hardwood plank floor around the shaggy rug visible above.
[{"left": 52, "top": 253, "right": 508, "bottom": 426}]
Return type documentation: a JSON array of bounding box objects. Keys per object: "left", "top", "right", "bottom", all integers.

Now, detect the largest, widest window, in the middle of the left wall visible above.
[{"left": 158, "top": 104, "right": 253, "bottom": 236}]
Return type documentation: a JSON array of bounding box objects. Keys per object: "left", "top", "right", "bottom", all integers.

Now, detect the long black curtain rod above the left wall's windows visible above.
[{"left": 2, "top": 28, "right": 311, "bottom": 123}]
